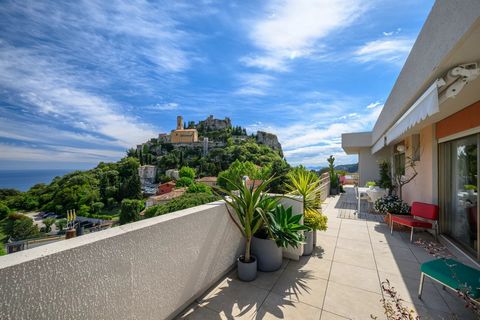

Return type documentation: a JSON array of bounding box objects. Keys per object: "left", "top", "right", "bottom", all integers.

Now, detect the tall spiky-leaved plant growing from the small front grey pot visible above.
[{"left": 215, "top": 177, "right": 275, "bottom": 263}]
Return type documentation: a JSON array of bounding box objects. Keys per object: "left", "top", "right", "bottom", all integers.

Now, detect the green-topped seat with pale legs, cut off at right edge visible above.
[{"left": 418, "top": 259, "right": 480, "bottom": 304}]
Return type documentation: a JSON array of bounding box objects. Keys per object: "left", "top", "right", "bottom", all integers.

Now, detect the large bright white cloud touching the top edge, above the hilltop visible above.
[{"left": 241, "top": 0, "right": 367, "bottom": 71}]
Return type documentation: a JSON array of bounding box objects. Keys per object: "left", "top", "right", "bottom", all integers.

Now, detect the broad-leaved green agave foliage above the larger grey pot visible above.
[{"left": 268, "top": 205, "right": 309, "bottom": 248}]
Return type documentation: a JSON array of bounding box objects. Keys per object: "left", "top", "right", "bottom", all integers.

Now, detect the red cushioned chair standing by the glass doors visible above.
[{"left": 390, "top": 202, "right": 438, "bottom": 242}]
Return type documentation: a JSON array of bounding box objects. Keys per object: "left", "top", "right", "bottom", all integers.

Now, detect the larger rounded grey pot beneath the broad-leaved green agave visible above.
[{"left": 252, "top": 237, "right": 283, "bottom": 272}]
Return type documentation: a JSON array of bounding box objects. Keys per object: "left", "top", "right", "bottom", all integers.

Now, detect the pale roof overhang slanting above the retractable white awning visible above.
[{"left": 372, "top": 1, "right": 480, "bottom": 142}]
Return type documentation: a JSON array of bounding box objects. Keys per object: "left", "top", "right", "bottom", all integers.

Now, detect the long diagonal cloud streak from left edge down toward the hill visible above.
[{"left": 0, "top": 45, "right": 158, "bottom": 148}]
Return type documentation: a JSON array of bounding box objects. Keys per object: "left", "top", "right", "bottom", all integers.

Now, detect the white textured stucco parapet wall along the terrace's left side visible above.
[{"left": 0, "top": 199, "right": 302, "bottom": 320}]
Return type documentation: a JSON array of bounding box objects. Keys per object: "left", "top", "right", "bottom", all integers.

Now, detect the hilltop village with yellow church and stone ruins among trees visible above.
[{"left": 128, "top": 115, "right": 283, "bottom": 202}]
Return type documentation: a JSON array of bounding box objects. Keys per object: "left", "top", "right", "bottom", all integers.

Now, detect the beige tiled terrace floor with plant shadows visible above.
[{"left": 179, "top": 188, "right": 475, "bottom": 320}]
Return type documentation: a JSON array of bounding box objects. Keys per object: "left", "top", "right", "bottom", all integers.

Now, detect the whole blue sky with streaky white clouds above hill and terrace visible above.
[{"left": 0, "top": 0, "right": 433, "bottom": 169}]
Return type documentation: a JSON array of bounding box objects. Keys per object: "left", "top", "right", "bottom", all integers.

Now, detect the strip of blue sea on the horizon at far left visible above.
[{"left": 0, "top": 169, "right": 81, "bottom": 192}]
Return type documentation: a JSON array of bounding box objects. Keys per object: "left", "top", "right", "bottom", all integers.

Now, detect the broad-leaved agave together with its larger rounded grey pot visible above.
[{"left": 252, "top": 202, "right": 308, "bottom": 272}]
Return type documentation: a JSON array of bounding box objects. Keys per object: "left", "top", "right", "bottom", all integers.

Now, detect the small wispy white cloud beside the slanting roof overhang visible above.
[{"left": 354, "top": 37, "right": 414, "bottom": 64}]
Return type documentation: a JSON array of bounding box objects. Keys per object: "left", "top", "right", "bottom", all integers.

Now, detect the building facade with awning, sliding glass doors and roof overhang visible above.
[{"left": 342, "top": 0, "right": 480, "bottom": 261}]
